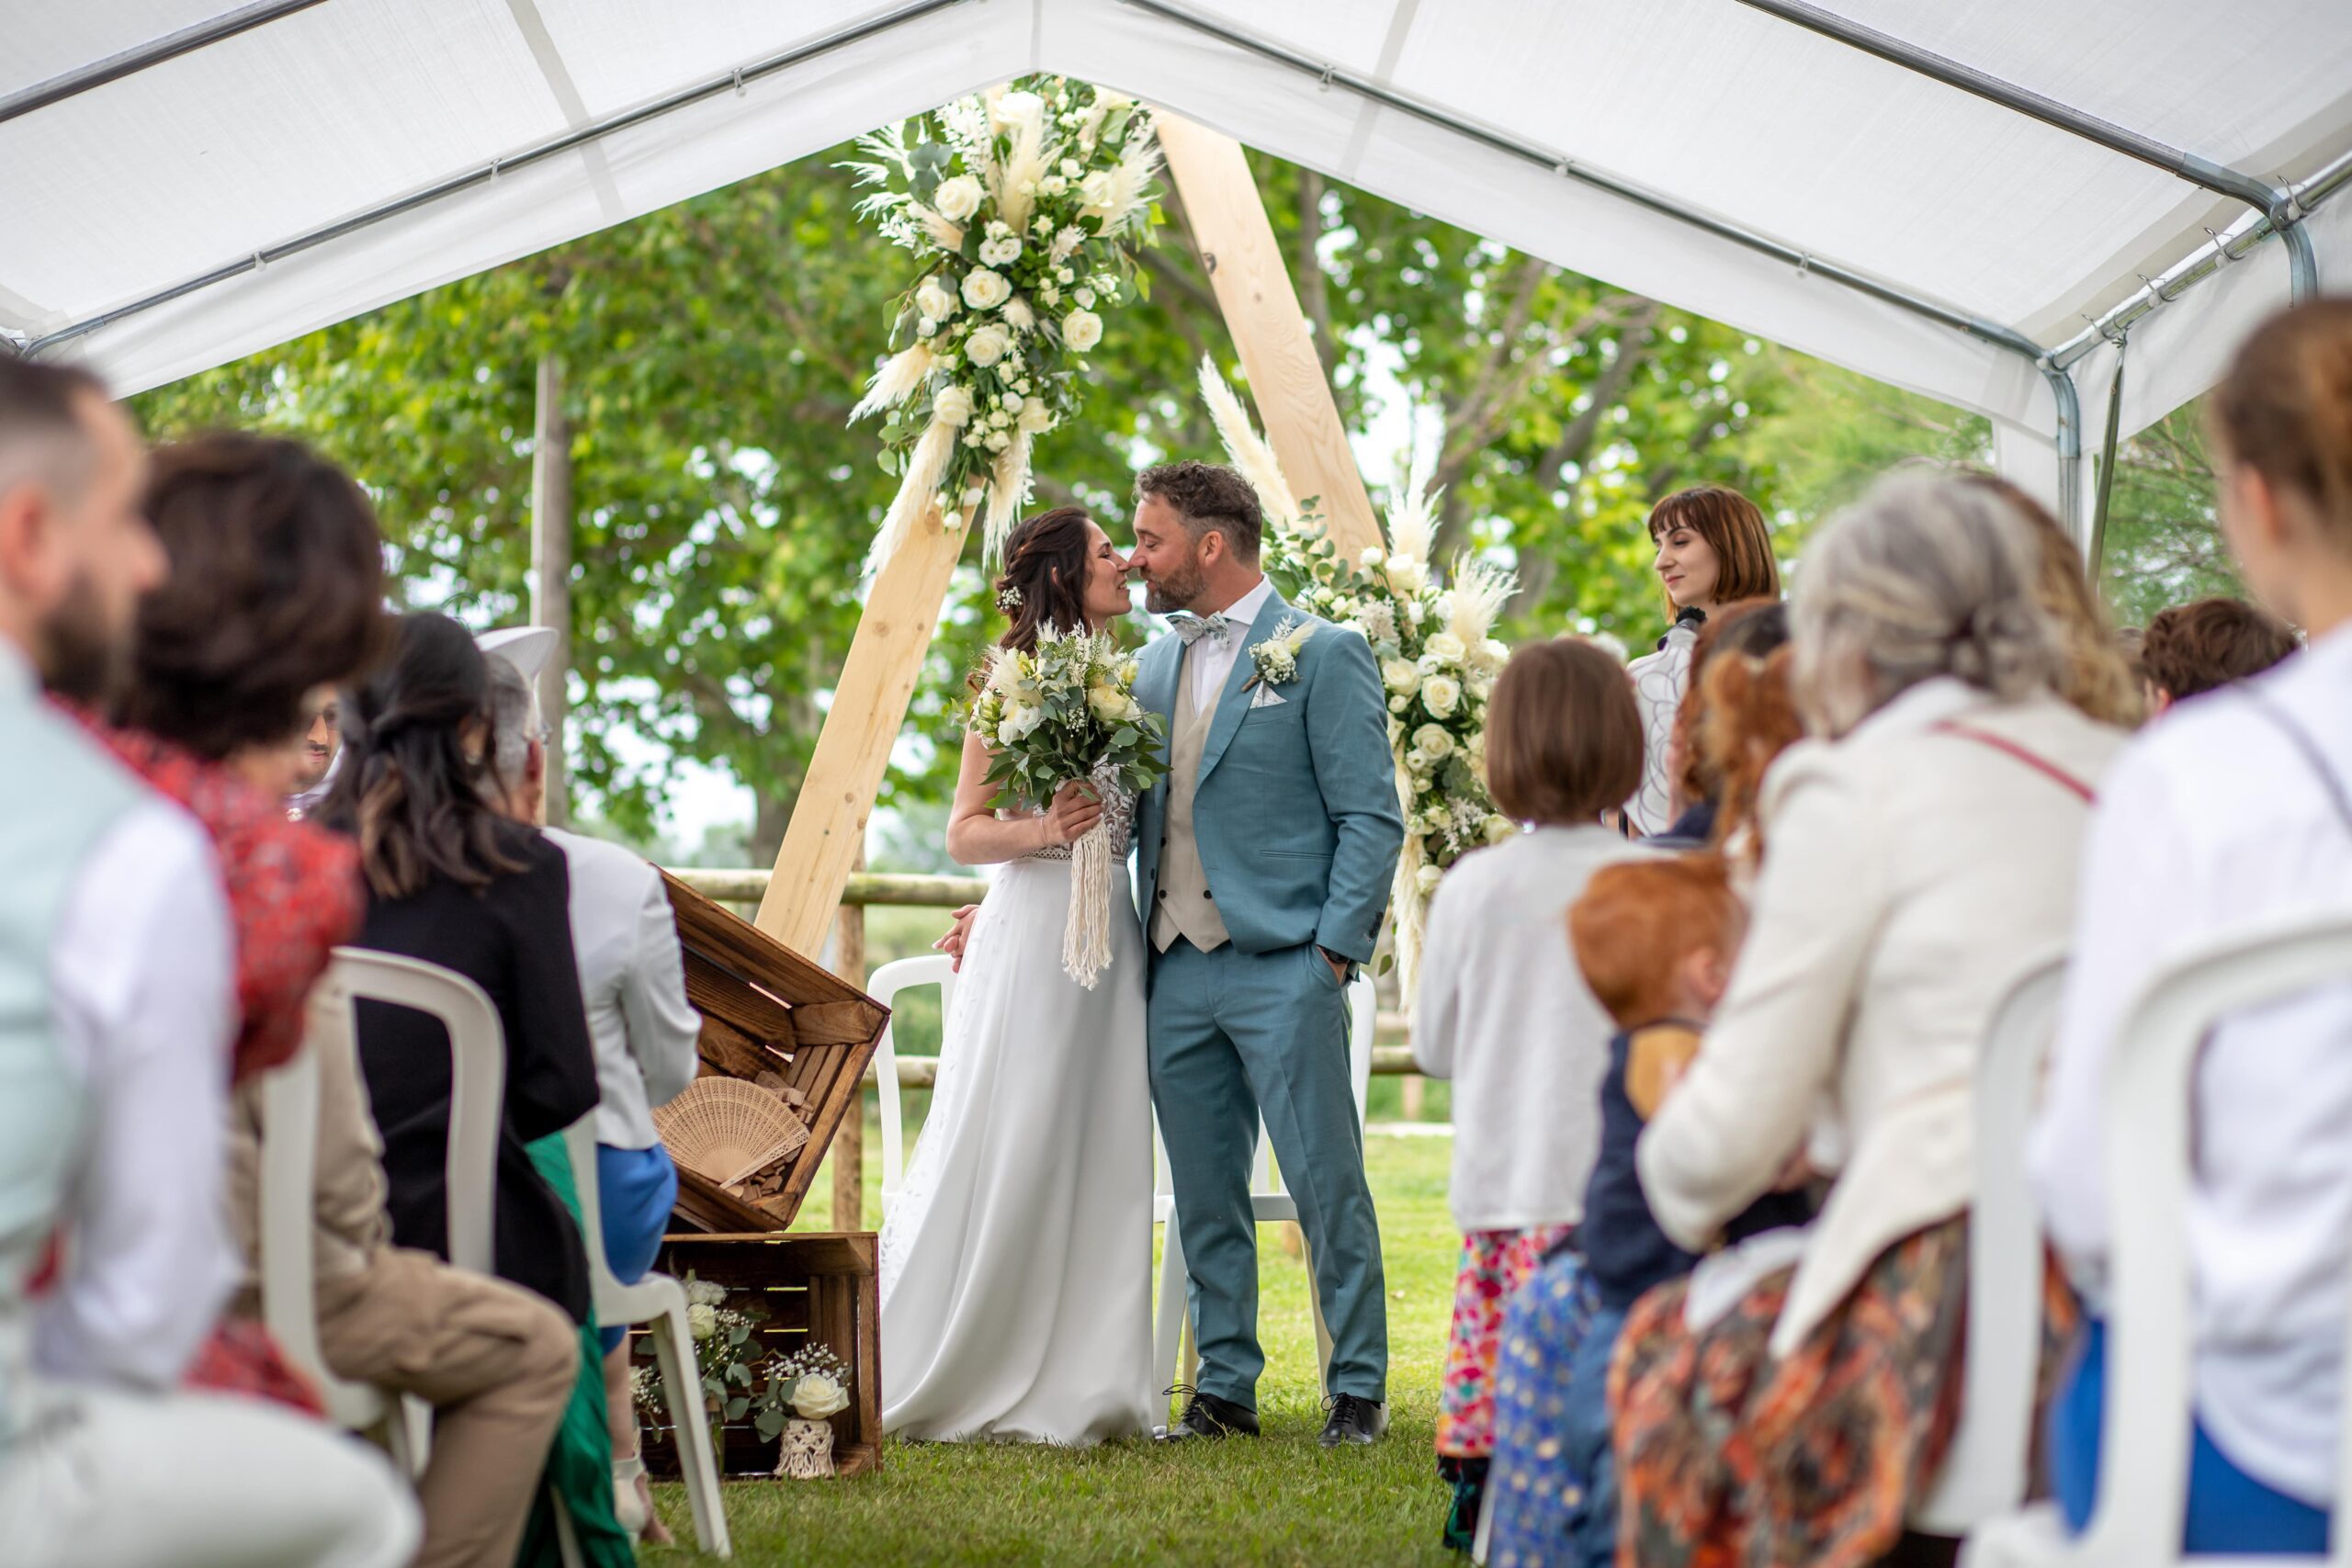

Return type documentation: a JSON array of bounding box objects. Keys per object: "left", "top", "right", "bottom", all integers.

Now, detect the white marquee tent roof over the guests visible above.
[{"left": 0, "top": 0, "right": 2352, "bottom": 536}]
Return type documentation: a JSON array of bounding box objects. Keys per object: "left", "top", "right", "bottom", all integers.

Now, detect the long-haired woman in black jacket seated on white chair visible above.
[{"left": 322, "top": 614, "right": 597, "bottom": 1321}]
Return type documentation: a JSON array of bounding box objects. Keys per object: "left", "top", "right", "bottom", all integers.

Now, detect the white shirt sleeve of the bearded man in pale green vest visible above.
[{"left": 33, "top": 799, "right": 238, "bottom": 1387}]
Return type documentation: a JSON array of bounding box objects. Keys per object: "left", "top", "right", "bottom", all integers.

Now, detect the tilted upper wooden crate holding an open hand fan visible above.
[{"left": 663, "top": 872, "right": 889, "bottom": 1235}]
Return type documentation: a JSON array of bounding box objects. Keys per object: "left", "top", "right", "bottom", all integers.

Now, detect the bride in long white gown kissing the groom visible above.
[{"left": 882, "top": 508, "right": 1152, "bottom": 1443}]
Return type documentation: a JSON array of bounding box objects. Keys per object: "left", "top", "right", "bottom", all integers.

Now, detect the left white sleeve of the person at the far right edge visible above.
[{"left": 2025, "top": 752, "right": 2199, "bottom": 1298}]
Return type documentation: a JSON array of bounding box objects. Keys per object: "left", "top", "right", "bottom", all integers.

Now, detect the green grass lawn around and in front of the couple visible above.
[{"left": 644, "top": 1123, "right": 1461, "bottom": 1565}]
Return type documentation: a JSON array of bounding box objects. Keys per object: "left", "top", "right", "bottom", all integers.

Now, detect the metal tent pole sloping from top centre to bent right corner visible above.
[{"left": 1125, "top": 0, "right": 2082, "bottom": 534}]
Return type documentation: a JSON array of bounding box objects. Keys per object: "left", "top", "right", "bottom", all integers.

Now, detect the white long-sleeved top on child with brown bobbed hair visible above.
[{"left": 1414, "top": 823, "right": 1656, "bottom": 1229}]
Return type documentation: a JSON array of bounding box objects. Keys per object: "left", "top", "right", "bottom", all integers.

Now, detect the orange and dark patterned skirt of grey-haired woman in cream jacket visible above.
[{"left": 1609, "top": 1218, "right": 1969, "bottom": 1568}]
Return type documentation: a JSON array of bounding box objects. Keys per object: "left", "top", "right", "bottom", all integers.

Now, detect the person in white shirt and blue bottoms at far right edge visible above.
[{"left": 2028, "top": 299, "right": 2352, "bottom": 1556}]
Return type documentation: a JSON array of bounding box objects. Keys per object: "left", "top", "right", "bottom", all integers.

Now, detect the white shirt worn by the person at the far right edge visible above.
[{"left": 2030, "top": 627, "right": 2352, "bottom": 1506}]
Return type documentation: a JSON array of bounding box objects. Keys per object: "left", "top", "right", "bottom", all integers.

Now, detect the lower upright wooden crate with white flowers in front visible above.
[{"left": 633, "top": 1232, "right": 882, "bottom": 1476}]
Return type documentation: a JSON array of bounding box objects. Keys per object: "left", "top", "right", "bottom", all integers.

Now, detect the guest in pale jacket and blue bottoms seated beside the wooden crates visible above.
[{"left": 482, "top": 632, "right": 703, "bottom": 1542}]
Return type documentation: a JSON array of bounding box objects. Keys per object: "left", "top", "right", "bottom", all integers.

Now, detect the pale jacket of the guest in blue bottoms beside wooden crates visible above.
[{"left": 546, "top": 828, "right": 703, "bottom": 1149}]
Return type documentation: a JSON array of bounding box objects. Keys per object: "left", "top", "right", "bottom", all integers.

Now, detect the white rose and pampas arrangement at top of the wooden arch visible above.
[{"left": 844, "top": 75, "right": 1159, "bottom": 564}]
